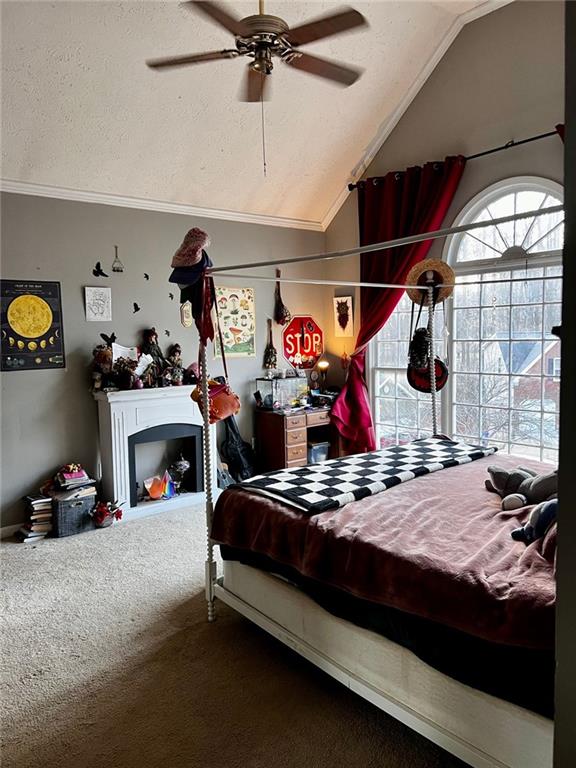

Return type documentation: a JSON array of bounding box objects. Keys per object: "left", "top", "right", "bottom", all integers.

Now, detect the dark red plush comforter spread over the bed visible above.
[{"left": 212, "top": 454, "right": 556, "bottom": 649}]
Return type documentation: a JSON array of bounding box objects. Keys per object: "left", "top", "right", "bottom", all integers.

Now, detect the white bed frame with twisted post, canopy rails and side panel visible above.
[{"left": 200, "top": 206, "right": 562, "bottom": 768}]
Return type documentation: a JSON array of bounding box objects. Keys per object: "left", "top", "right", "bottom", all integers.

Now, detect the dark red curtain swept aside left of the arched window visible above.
[{"left": 331, "top": 156, "right": 466, "bottom": 453}]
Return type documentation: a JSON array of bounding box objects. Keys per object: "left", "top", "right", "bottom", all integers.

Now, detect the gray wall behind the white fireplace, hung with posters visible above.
[{"left": 1, "top": 194, "right": 326, "bottom": 525}]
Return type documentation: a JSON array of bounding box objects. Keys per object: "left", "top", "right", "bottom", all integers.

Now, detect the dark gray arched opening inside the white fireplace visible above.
[{"left": 128, "top": 424, "right": 204, "bottom": 507}]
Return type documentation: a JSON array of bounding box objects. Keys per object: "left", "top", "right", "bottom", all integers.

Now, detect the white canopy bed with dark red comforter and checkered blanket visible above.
[{"left": 181, "top": 196, "right": 562, "bottom": 768}]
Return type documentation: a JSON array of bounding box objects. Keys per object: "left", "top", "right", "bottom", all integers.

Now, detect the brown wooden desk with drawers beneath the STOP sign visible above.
[{"left": 254, "top": 408, "right": 330, "bottom": 472}]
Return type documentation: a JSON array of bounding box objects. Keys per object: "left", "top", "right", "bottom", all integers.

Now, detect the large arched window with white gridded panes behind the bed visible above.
[{"left": 370, "top": 177, "right": 564, "bottom": 462}]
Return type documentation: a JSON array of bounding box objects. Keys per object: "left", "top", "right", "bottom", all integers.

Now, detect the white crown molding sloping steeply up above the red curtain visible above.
[{"left": 322, "top": 0, "right": 514, "bottom": 231}]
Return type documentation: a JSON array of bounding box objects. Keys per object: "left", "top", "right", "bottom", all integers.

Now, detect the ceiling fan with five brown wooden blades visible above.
[{"left": 146, "top": 0, "right": 367, "bottom": 101}]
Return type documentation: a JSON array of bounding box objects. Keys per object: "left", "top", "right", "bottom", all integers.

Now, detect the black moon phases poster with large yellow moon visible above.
[{"left": 0, "top": 280, "right": 65, "bottom": 371}]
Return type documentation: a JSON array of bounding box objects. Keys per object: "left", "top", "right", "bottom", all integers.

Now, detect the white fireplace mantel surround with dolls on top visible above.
[{"left": 94, "top": 386, "right": 216, "bottom": 520}]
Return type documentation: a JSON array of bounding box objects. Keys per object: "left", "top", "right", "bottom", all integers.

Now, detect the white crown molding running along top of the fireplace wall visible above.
[{"left": 0, "top": 179, "right": 324, "bottom": 232}]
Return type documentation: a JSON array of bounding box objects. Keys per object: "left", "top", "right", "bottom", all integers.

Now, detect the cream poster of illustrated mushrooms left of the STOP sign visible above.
[{"left": 216, "top": 286, "right": 256, "bottom": 357}]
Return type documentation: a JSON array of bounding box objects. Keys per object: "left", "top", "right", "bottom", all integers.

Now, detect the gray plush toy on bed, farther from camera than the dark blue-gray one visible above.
[{"left": 486, "top": 465, "right": 558, "bottom": 510}]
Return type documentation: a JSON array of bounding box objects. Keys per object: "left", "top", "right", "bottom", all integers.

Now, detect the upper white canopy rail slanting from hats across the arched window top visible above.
[{"left": 206, "top": 205, "right": 564, "bottom": 275}]
